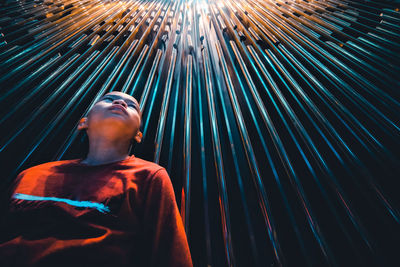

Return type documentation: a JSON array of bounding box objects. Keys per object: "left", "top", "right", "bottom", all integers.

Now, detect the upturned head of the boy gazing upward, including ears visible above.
[{"left": 78, "top": 92, "right": 142, "bottom": 143}]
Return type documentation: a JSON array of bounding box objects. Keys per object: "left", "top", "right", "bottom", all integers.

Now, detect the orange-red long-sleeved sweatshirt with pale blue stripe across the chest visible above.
[{"left": 0, "top": 156, "right": 193, "bottom": 267}]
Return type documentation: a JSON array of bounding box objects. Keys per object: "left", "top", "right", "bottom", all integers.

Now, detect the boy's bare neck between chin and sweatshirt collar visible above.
[{"left": 82, "top": 137, "right": 130, "bottom": 165}]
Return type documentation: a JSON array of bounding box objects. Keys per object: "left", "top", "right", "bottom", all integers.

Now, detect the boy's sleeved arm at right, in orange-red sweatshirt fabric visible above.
[{"left": 144, "top": 168, "right": 193, "bottom": 267}]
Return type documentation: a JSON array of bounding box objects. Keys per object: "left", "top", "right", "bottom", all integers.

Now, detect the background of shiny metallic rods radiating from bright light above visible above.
[{"left": 0, "top": 0, "right": 400, "bottom": 266}]
